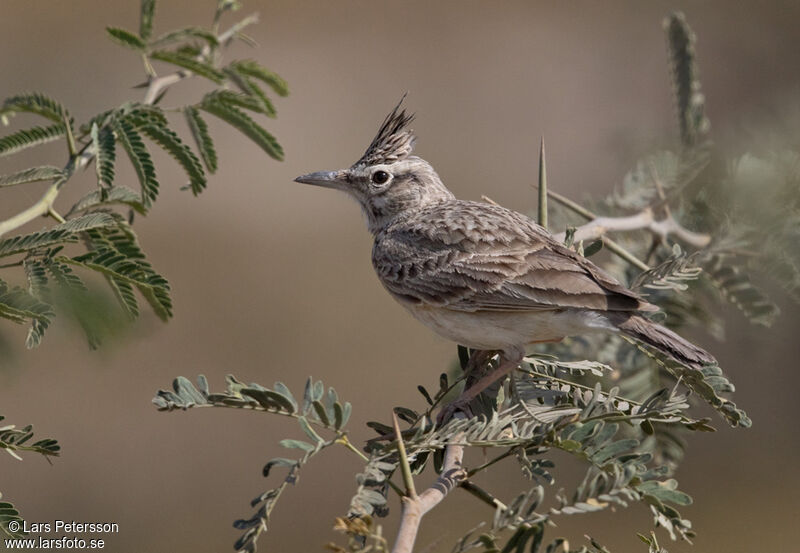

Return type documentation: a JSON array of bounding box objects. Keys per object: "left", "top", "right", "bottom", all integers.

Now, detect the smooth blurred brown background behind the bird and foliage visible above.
[{"left": 0, "top": 0, "right": 800, "bottom": 553}]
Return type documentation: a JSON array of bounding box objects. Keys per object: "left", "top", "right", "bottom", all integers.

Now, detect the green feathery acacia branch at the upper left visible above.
[{"left": 0, "top": 0, "right": 288, "bottom": 348}]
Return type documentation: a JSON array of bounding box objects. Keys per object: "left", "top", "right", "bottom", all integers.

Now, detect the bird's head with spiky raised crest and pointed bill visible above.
[{"left": 294, "top": 100, "right": 453, "bottom": 233}]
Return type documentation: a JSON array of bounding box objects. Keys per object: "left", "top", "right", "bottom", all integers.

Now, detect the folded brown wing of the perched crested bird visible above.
[{"left": 373, "top": 201, "right": 656, "bottom": 312}]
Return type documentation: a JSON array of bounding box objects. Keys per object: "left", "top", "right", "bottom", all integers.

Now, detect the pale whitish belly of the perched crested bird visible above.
[{"left": 404, "top": 304, "right": 616, "bottom": 350}]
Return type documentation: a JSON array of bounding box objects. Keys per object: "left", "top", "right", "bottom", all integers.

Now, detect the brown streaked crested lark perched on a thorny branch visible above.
[{"left": 295, "top": 99, "right": 716, "bottom": 422}]
